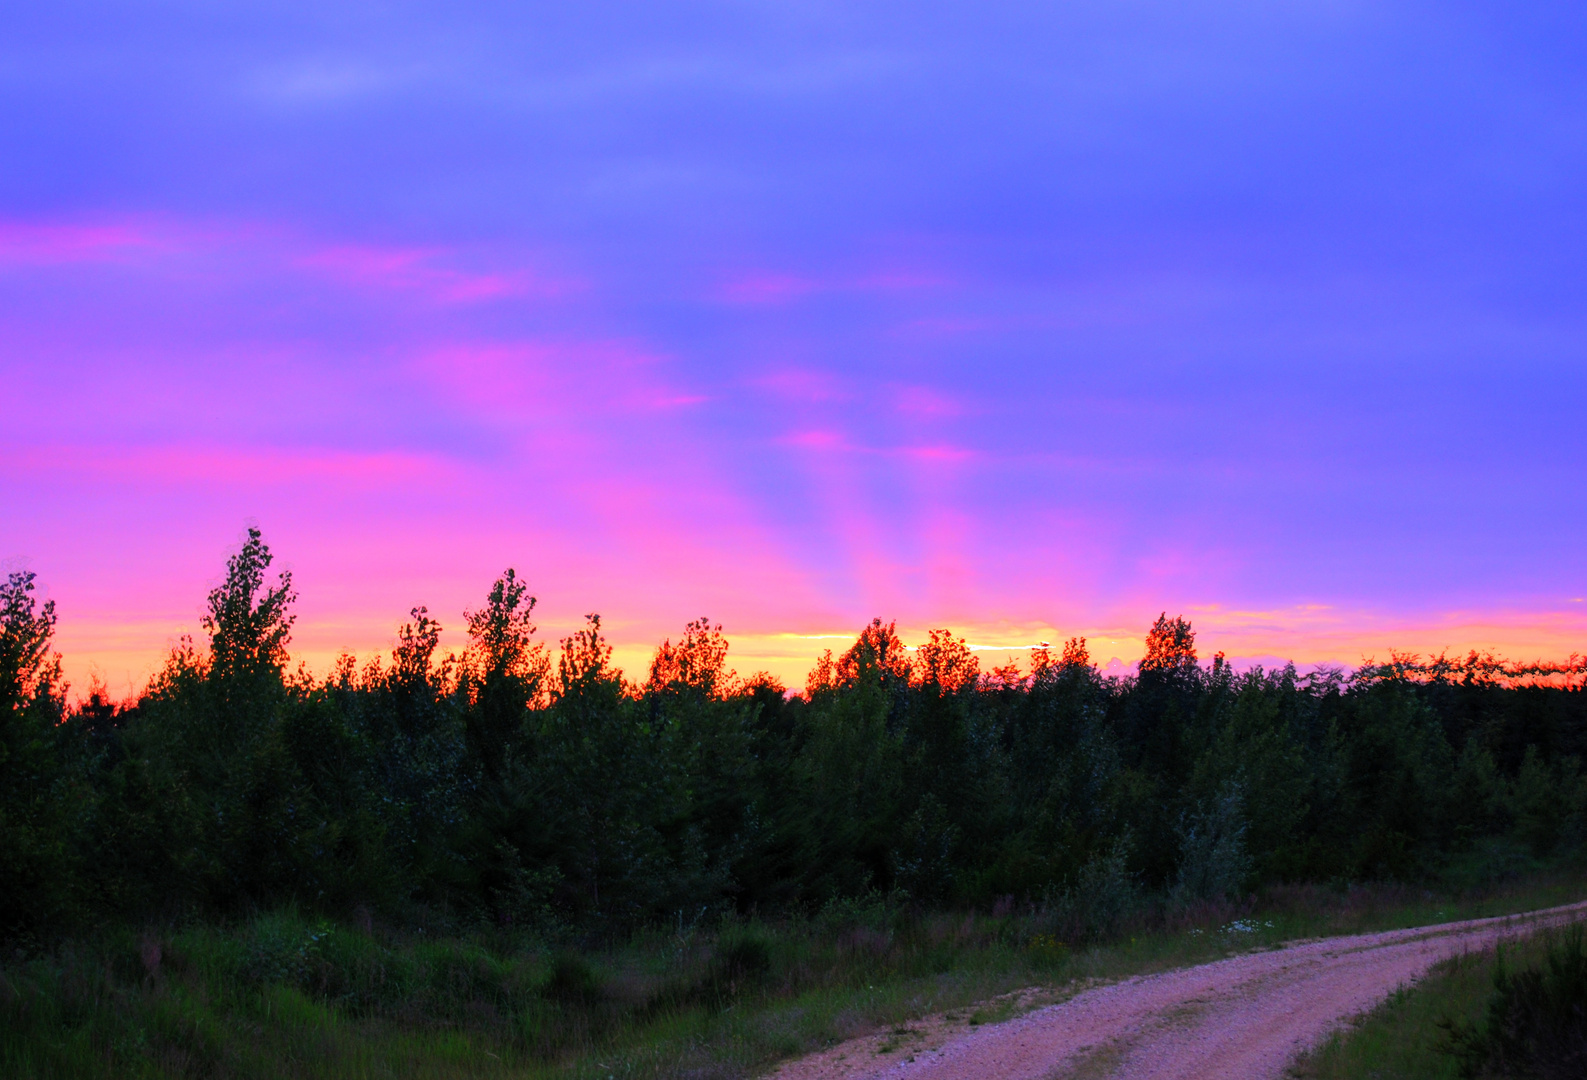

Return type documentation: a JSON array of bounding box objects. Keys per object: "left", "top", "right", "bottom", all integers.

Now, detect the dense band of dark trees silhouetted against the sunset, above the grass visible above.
[{"left": 0, "top": 530, "right": 1587, "bottom": 937}]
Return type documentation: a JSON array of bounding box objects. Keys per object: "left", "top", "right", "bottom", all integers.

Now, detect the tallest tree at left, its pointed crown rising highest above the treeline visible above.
[{"left": 102, "top": 528, "right": 312, "bottom": 909}]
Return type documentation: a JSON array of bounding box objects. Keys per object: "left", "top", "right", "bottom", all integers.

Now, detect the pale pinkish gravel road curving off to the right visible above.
[{"left": 773, "top": 902, "right": 1587, "bottom": 1080}]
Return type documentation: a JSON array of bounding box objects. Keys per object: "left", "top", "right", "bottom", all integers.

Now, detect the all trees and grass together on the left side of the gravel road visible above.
[{"left": 0, "top": 531, "right": 1587, "bottom": 1077}]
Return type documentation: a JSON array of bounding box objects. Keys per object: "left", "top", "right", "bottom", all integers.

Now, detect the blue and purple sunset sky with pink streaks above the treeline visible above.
[{"left": 0, "top": 0, "right": 1587, "bottom": 695}]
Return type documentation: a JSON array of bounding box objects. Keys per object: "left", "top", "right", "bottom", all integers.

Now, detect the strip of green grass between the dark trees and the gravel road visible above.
[{"left": 9, "top": 875, "right": 1587, "bottom": 1080}]
